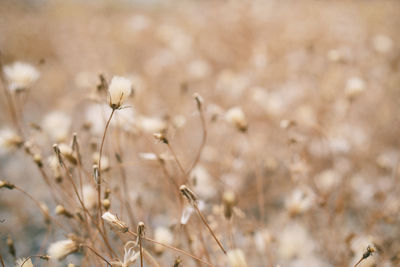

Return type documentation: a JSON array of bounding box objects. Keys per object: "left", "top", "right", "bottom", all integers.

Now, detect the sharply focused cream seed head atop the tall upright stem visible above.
[{"left": 108, "top": 76, "right": 132, "bottom": 109}]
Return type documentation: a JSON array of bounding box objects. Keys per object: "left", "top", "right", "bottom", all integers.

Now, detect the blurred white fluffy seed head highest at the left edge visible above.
[{"left": 3, "top": 62, "right": 40, "bottom": 91}]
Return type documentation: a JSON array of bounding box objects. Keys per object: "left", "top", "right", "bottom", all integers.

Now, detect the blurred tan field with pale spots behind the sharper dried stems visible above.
[{"left": 0, "top": 0, "right": 400, "bottom": 267}]
